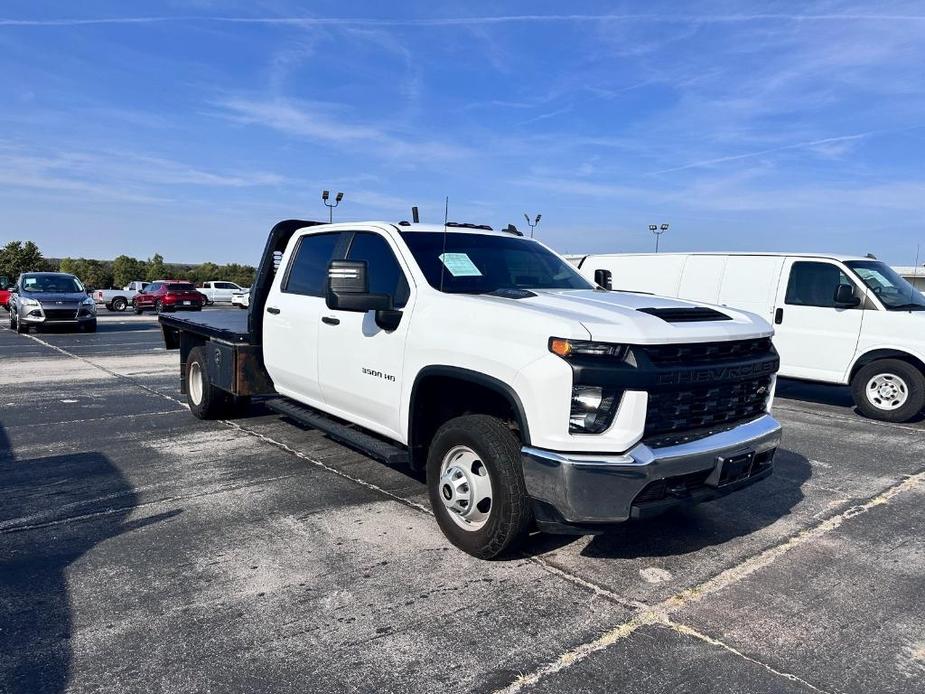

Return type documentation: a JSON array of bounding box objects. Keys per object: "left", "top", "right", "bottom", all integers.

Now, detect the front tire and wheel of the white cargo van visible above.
[{"left": 851, "top": 359, "right": 925, "bottom": 422}]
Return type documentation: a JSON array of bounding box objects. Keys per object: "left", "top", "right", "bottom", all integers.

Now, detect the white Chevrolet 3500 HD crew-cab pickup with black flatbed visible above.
[{"left": 160, "top": 220, "right": 781, "bottom": 558}]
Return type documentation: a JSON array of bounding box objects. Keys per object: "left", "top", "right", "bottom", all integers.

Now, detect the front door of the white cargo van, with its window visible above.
[{"left": 774, "top": 258, "right": 866, "bottom": 383}]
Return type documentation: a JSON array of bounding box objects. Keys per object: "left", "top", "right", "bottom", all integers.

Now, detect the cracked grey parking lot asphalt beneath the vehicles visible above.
[{"left": 0, "top": 311, "right": 925, "bottom": 692}]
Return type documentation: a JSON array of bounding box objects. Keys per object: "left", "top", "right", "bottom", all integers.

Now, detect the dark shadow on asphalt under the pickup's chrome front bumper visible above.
[{"left": 526, "top": 450, "right": 812, "bottom": 559}]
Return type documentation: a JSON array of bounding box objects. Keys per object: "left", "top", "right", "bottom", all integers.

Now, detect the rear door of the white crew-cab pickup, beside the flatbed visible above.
[{"left": 262, "top": 232, "right": 346, "bottom": 407}]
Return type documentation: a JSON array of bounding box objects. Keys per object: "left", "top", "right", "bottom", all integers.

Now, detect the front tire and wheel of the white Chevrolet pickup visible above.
[{"left": 427, "top": 415, "right": 533, "bottom": 559}]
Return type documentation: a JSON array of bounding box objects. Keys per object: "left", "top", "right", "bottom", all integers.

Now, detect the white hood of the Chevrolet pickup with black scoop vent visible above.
[{"left": 512, "top": 289, "right": 773, "bottom": 344}]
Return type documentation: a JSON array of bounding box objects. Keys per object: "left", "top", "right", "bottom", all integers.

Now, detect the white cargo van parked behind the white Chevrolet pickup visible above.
[{"left": 569, "top": 253, "right": 925, "bottom": 422}]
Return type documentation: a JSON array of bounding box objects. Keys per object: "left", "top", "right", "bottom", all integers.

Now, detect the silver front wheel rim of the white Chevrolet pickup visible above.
[{"left": 440, "top": 446, "right": 492, "bottom": 530}]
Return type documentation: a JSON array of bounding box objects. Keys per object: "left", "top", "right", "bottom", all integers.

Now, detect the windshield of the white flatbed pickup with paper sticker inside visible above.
[{"left": 402, "top": 231, "right": 594, "bottom": 294}]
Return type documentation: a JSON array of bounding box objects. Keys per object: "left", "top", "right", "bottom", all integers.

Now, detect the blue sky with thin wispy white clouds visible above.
[{"left": 0, "top": 0, "right": 925, "bottom": 264}]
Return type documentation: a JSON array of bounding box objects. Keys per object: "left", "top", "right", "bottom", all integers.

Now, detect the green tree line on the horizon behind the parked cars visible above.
[{"left": 0, "top": 241, "right": 257, "bottom": 289}]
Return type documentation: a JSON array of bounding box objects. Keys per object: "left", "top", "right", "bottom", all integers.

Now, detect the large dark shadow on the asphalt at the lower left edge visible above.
[{"left": 0, "top": 425, "right": 180, "bottom": 694}]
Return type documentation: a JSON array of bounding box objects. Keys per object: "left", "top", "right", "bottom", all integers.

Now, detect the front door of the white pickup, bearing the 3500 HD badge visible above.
[{"left": 318, "top": 231, "right": 413, "bottom": 440}]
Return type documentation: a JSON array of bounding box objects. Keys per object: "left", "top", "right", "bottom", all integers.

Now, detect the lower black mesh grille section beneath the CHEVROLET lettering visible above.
[{"left": 643, "top": 375, "right": 773, "bottom": 445}]
